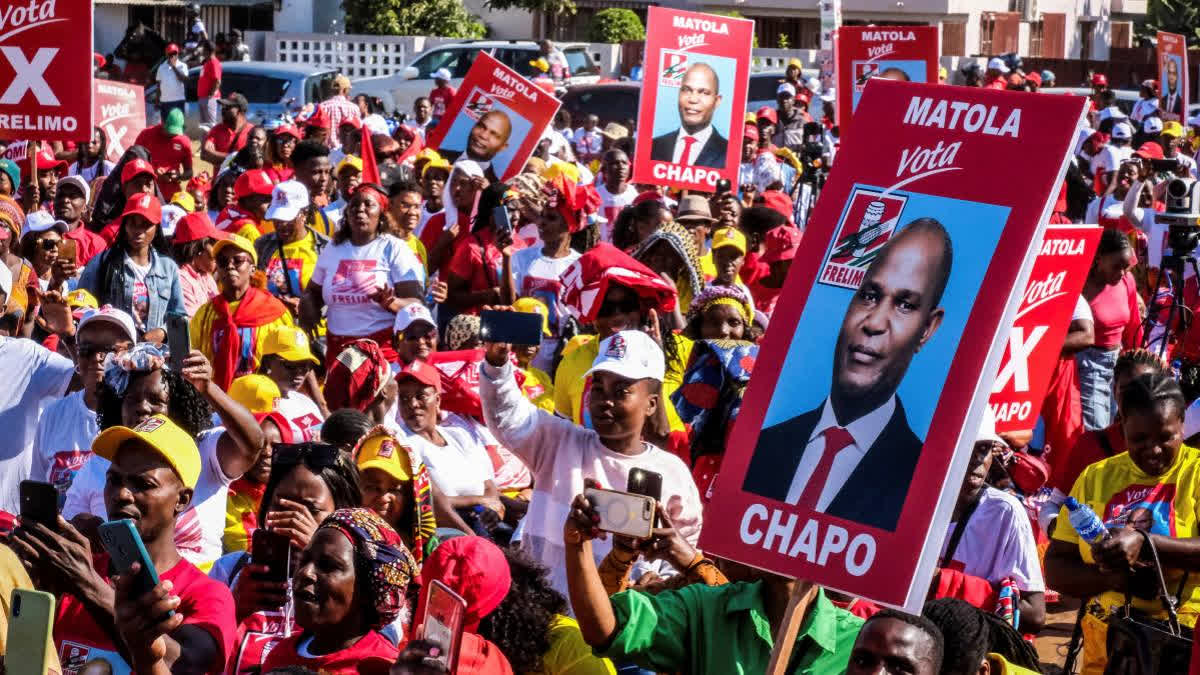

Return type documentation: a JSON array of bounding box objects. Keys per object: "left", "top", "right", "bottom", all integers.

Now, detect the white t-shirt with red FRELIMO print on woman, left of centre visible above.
[{"left": 310, "top": 234, "right": 425, "bottom": 336}]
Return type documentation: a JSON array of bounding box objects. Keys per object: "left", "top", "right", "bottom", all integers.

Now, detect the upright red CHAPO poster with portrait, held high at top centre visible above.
[{"left": 634, "top": 6, "right": 754, "bottom": 192}]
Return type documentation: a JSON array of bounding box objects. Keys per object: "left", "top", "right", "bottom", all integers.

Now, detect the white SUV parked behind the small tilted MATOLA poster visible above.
[{"left": 350, "top": 40, "right": 600, "bottom": 113}]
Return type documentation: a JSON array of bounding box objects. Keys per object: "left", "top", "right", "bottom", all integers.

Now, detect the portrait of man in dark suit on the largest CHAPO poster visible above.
[{"left": 743, "top": 217, "right": 953, "bottom": 531}]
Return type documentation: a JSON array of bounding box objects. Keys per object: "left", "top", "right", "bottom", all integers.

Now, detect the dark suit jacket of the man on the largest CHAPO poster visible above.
[{"left": 742, "top": 399, "right": 924, "bottom": 532}]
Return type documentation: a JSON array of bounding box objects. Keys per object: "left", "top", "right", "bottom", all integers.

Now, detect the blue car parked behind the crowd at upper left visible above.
[{"left": 145, "top": 61, "right": 337, "bottom": 138}]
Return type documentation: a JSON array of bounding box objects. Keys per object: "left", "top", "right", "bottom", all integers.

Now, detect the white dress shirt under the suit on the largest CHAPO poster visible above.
[{"left": 786, "top": 395, "right": 896, "bottom": 513}]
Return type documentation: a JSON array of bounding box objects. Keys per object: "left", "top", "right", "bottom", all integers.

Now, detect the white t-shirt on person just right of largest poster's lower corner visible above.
[{"left": 941, "top": 486, "right": 1046, "bottom": 593}]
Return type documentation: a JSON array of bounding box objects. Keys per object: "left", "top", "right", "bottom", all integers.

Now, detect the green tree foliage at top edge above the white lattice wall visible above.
[{"left": 342, "top": 0, "right": 486, "bottom": 38}]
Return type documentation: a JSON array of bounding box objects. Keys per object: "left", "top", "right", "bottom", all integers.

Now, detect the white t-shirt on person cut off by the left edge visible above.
[{"left": 0, "top": 338, "right": 74, "bottom": 514}]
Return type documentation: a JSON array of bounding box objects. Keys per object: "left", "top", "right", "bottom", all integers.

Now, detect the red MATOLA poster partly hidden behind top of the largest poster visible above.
[{"left": 834, "top": 25, "right": 940, "bottom": 138}]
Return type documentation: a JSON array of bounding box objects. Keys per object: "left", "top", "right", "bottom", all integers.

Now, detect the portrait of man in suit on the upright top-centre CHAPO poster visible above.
[{"left": 650, "top": 64, "right": 730, "bottom": 168}]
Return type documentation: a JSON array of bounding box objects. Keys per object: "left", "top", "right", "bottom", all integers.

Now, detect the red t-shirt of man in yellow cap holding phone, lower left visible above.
[{"left": 54, "top": 554, "right": 238, "bottom": 675}]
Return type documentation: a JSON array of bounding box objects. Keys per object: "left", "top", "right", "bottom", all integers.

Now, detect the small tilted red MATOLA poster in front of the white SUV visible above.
[{"left": 428, "top": 52, "right": 562, "bottom": 183}]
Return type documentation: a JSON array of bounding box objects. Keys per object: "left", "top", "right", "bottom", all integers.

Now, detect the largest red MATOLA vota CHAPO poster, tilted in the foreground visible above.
[{"left": 700, "top": 79, "right": 1085, "bottom": 613}]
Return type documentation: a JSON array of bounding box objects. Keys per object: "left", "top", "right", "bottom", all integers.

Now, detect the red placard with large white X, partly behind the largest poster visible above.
[{"left": 988, "top": 225, "right": 1100, "bottom": 432}]
